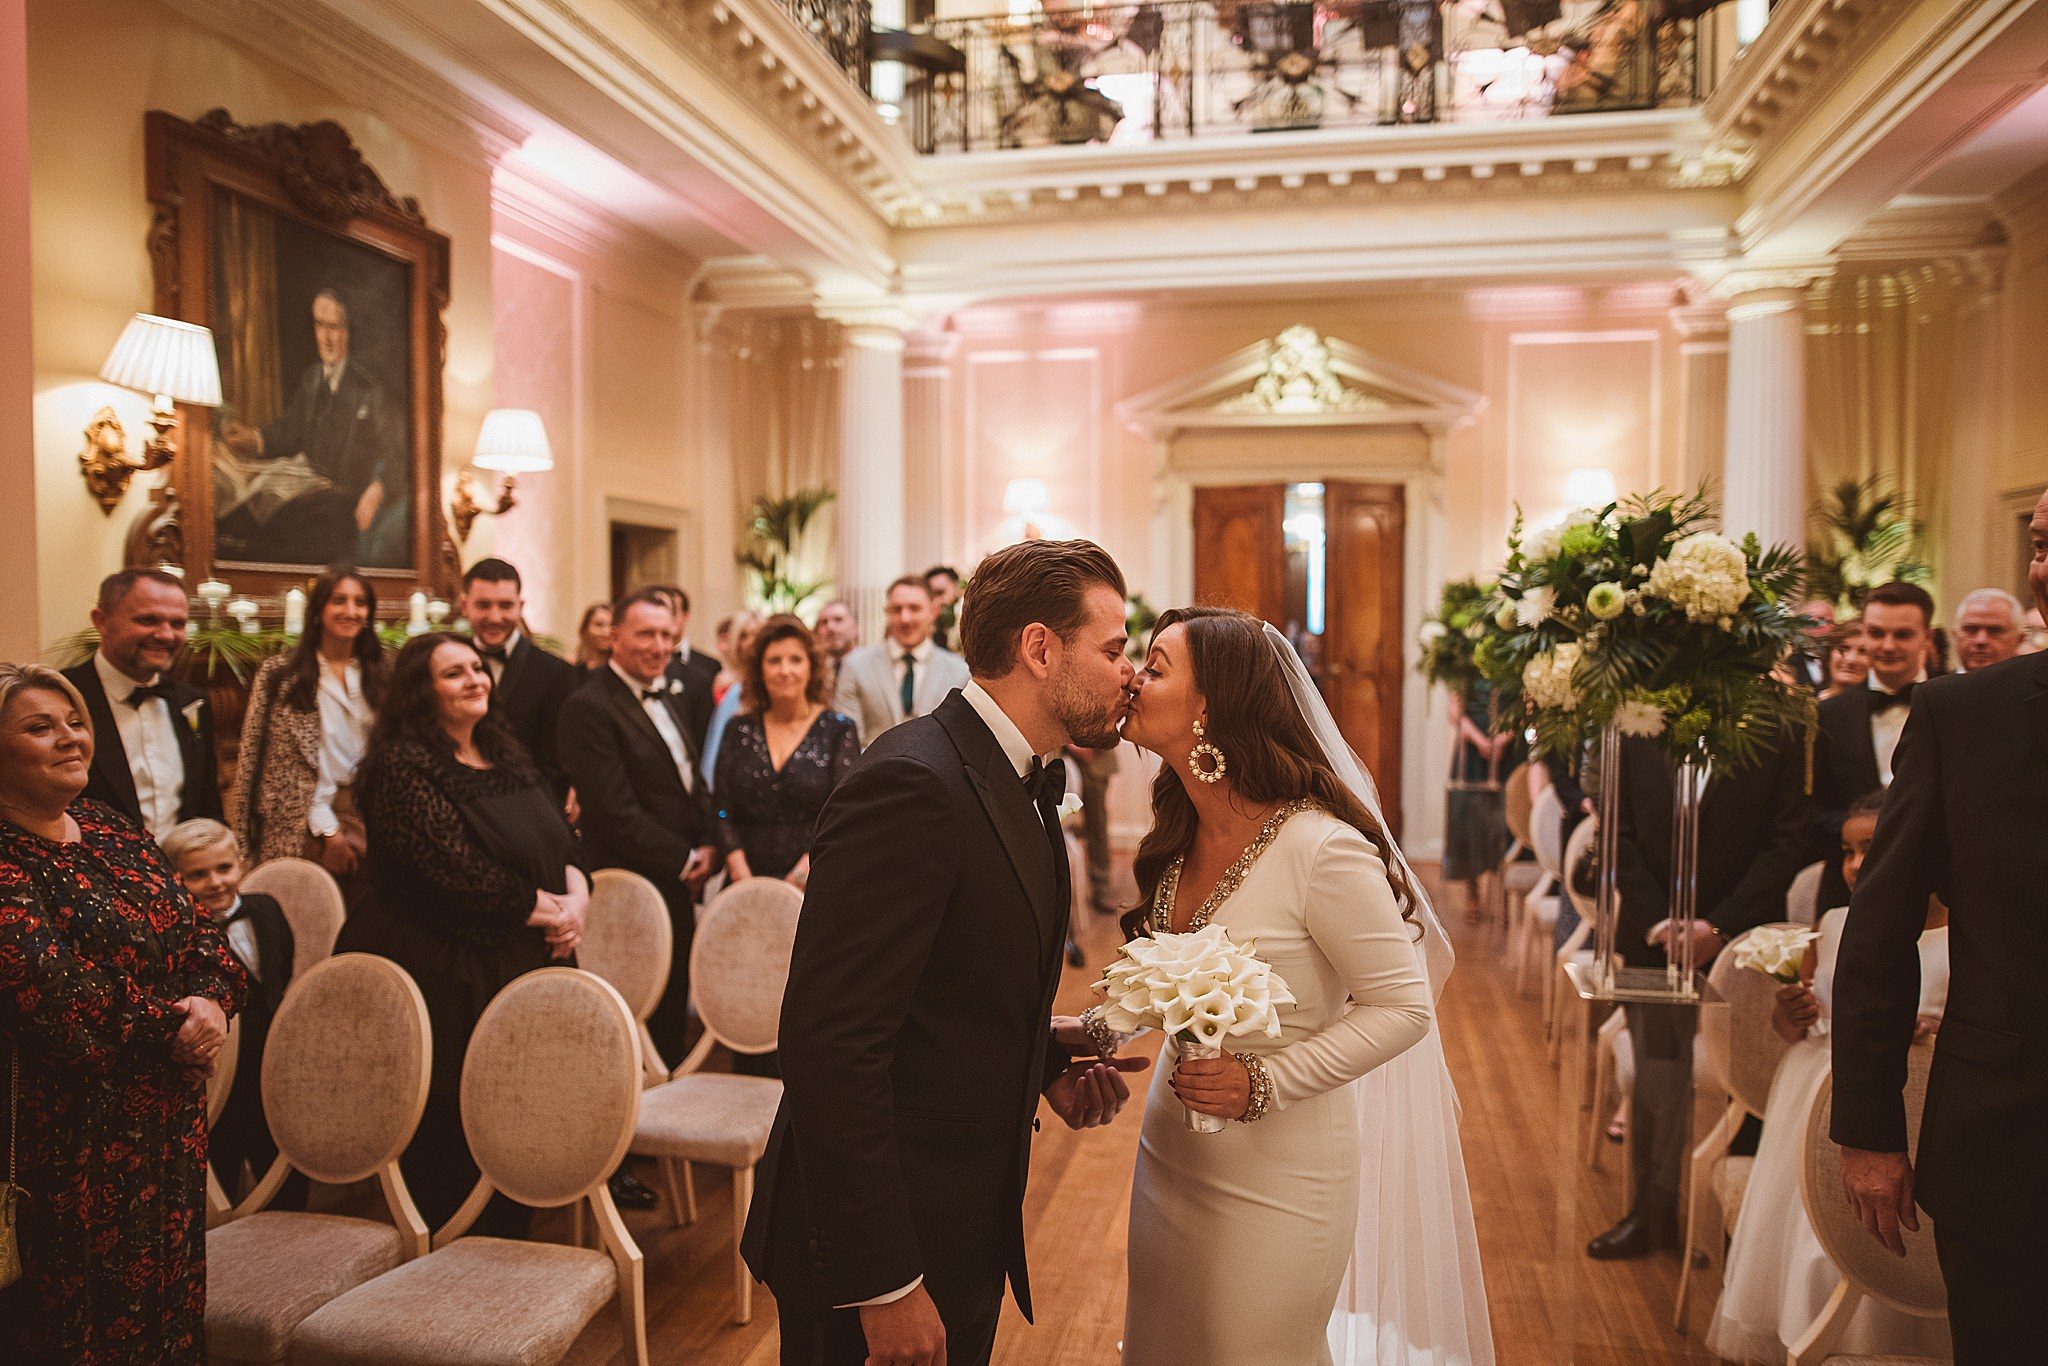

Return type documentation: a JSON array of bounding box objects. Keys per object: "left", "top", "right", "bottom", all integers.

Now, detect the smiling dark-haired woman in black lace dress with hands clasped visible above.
[{"left": 336, "top": 631, "right": 590, "bottom": 1237}]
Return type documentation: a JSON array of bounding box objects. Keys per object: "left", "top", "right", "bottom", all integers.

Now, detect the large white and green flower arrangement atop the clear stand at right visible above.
[{"left": 1477, "top": 489, "right": 1812, "bottom": 766}]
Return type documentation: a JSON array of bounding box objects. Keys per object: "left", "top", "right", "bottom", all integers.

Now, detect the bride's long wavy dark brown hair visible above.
[{"left": 1122, "top": 606, "right": 1415, "bottom": 938}]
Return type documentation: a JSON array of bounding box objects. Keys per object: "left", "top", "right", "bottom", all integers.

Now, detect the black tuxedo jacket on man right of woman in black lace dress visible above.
[{"left": 555, "top": 668, "right": 717, "bottom": 895}]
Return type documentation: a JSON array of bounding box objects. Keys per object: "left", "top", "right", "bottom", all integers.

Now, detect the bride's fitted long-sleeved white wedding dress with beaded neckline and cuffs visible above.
[{"left": 1124, "top": 807, "right": 1441, "bottom": 1366}]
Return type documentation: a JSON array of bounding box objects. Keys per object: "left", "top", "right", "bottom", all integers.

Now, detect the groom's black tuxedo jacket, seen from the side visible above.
[{"left": 743, "top": 692, "right": 1067, "bottom": 1319}]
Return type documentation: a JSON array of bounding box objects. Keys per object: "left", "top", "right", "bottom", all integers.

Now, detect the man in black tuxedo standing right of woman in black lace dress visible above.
[{"left": 555, "top": 590, "right": 715, "bottom": 1067}]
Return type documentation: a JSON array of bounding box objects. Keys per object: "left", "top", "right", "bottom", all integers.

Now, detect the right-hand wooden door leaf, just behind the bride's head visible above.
[{"left": 1323, "top": 481, "right": 1407, "bottom": 838}]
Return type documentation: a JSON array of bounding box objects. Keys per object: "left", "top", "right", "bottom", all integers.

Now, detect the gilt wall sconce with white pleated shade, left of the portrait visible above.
[{"left": 78, "top": 313, "right": 221, "bottom": 512}]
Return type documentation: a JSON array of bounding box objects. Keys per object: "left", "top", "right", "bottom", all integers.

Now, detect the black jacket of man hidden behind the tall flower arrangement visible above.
[{"left": 1599, "top": 735, "right": 1812, "bottom": 967}]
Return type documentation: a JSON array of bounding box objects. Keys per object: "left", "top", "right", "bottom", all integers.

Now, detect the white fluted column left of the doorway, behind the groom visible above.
[{"left": 836, "top": 309, "right": 911, "bottom": 641}]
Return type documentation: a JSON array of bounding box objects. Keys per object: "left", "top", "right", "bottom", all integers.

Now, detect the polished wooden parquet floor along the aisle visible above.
[{"left": 552, "top": 868, "right": 1712, "bottom": 1366}]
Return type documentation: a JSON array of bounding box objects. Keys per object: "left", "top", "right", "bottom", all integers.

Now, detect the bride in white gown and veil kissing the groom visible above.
[{"left": 1061, "top": 608, "right": 1493, "bottom": 1366}]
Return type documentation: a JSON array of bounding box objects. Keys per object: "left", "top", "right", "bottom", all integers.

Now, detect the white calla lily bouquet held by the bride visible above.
[{"left": 1096, "top": 926, "right": 1294, "bottom": 1133}]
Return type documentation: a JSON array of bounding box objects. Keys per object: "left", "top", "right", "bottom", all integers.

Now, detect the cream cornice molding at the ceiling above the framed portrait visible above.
[{"left": 164, "top": 0, "right": 530, "bottom": 168}]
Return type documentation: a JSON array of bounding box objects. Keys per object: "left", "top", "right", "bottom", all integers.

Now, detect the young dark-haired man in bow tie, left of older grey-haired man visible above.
[{"left": 1810, "top": 584, "right": 1933, "bottom": 909}]
